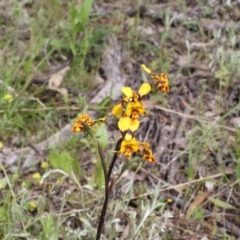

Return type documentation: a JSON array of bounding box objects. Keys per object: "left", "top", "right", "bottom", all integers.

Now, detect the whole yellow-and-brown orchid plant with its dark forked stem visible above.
[{"left": 72, "top": 64, "right": 169, "bottom": 240}]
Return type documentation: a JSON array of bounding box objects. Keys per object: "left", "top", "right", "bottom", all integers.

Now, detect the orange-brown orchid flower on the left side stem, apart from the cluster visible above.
[{"left": 72, "top": 114, "right": 106, "bottom": 132}]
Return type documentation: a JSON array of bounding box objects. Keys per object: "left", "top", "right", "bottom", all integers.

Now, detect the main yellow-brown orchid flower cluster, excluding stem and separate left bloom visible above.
[{"left": 112, "top": 64, "right": 169, "bottom": 163}]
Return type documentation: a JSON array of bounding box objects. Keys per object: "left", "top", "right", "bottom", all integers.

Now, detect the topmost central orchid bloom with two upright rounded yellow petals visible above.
[{"left": 121, "top": 83, "right": 151, "bottom": 102}]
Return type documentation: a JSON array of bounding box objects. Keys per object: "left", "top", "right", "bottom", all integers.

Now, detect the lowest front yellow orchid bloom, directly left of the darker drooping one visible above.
[{"left": 118, "top": 134, "right": 141, "bottom": 159}]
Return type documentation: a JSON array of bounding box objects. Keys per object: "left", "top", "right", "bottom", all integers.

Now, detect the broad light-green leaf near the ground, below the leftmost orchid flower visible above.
[{"left": 48, "top": 151, "right": 80, "bottom": 176}]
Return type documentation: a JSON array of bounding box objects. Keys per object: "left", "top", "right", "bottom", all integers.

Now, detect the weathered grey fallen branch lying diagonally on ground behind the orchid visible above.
[{"left": 0, "top": 38, "right": 126, "bottom": 172}]
